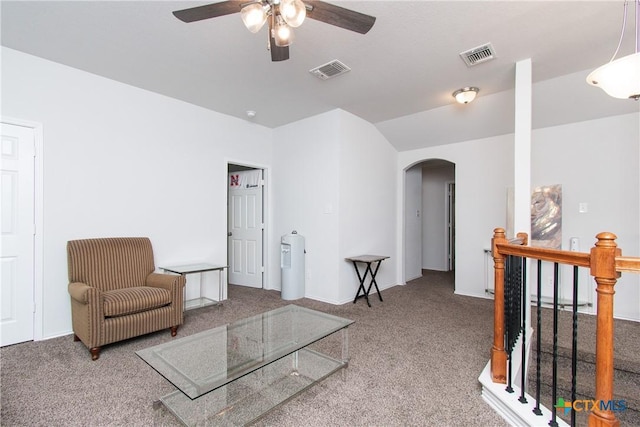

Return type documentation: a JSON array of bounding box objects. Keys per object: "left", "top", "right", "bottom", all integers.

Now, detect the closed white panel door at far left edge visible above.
[{"left": 0, "top": 123, "right": 35, "bottom": 346}]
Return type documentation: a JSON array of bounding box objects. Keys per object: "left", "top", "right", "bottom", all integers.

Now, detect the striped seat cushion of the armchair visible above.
[{"left": 102, "top": 286, "right": 172, "bottom": 317}]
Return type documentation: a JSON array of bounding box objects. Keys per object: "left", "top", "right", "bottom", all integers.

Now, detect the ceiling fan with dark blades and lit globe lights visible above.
[{"left": 173, "top": 0, "right": 376, "bottom": 61}]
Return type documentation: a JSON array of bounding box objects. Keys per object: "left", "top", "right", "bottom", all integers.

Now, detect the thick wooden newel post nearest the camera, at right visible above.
[{"left": 589, "top": 233, "right": 621, "bottom": 426}]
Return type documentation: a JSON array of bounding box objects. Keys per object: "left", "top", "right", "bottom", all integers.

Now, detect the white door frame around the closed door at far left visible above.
[{"left": 0, "top": 116, "right": 44, "bottom": 341}]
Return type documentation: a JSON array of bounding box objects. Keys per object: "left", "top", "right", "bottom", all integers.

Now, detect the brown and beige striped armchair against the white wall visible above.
[{"left": 67, "top": 237, "right": 185, "bottom": 360}]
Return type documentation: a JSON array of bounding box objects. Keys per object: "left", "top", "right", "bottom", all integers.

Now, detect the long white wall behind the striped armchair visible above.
[{"left": 2, "top": 48, "right": 271, "bottom": 338}]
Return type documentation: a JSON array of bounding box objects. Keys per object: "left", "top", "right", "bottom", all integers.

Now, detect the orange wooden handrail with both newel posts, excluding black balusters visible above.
[{"left": 491, "top": 228, "right": 640, "bottom": 426}]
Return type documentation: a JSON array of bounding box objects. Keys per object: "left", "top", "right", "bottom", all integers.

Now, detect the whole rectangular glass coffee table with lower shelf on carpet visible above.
[{"left": 136, "top": 305, "right": 353, "bottom": 426}]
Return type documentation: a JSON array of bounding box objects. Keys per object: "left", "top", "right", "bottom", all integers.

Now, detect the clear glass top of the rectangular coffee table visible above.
[{"left": 136, "top": 305, "right": 353, "bottom": 399}]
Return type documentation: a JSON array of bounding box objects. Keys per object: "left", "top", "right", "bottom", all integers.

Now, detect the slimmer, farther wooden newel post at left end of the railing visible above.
[{"left": 491, "top": 228, "right": 508, "bottom": 384}]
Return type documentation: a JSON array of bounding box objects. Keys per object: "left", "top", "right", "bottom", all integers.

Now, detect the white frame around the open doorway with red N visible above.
[{"left": 224, "top": 158, "right": 271, "bottom": 289}]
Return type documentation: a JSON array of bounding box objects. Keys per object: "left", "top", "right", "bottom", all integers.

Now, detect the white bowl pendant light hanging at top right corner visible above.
[{"left": 587, "top": 0, "right": 640, "bottom": 101}]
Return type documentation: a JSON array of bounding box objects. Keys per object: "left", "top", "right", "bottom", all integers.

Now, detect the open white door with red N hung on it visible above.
[{"left": 228, "top": 169, "right": 264, "bottom": 288}]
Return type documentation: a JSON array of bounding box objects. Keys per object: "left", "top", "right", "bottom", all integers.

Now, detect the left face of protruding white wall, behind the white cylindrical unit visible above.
[{"left": 271, "top": 110, "right": 340, "bottom": 302}]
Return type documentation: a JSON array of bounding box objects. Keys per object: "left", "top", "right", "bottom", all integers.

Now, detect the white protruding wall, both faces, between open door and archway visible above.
[{"left": 271, "top": 110, "right": 396, "bottom": 304}]
